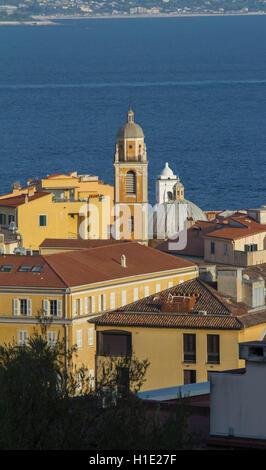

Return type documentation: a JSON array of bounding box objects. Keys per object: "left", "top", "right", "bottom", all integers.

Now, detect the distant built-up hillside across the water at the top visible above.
[{"left": 0, "top": 0, "right": 266, "bottom": 21}]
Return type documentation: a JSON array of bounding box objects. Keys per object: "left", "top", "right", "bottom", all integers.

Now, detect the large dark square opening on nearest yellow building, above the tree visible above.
[{"left": 97, "top": 330, "right": 132, "bottom": 356}]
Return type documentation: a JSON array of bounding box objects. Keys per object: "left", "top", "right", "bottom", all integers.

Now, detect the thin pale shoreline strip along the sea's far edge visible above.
[{"left": 0, "top": 11, "right": 266, "bottom": 26}]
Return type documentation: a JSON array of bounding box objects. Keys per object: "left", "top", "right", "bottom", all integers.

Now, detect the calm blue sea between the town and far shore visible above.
[{"left": 0, "top": 16, "right": 266, "bottom": 210}]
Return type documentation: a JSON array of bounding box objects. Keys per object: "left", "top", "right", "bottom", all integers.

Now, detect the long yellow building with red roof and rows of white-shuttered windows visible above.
[{"left": 0, "top": 241, "right": 198, "bottom": 376}]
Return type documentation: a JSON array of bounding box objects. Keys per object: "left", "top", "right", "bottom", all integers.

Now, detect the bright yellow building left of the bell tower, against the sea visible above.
[{"left": 0, "top": 173, "right": 113, "bottom": 251}]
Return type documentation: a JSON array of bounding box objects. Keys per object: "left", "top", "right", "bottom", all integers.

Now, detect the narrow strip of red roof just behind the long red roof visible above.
[{"left": 40, "top": 238, "right": 128, "bottom": 249}]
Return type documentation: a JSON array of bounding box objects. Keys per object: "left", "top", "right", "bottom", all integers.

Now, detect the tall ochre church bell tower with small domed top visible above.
[{"left": 114, "top": 106, "right": 148, "bottom": 244}]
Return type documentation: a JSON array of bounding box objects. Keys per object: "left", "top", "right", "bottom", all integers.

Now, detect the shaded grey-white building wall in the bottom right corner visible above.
[{"left": 210, "top": 341, "right": 266, "bottom": 440}]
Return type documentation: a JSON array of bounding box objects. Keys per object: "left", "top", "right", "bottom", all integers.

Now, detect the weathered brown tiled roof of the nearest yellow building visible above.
[{"left": 91, "top": 278, "right": 256, "bottom": 329}]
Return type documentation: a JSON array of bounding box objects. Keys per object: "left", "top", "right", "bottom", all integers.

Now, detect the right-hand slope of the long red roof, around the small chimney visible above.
[{"left": 44, "top": 242, "right": 196, "bottom": 287}]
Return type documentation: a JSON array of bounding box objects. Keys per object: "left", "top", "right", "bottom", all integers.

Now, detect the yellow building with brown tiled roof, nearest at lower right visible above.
[{"left": 90, "top": 271, "right": 266, "bottom": 392}]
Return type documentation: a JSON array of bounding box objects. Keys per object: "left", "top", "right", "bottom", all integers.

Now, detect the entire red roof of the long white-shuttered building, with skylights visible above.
[{"left": 0, "top": 242, "right": 196, "bottom": 287}]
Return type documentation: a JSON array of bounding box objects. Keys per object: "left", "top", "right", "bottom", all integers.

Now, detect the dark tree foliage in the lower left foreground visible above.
[{"left": 0, "top": 325, "right": 202, "bottom": 450}]
